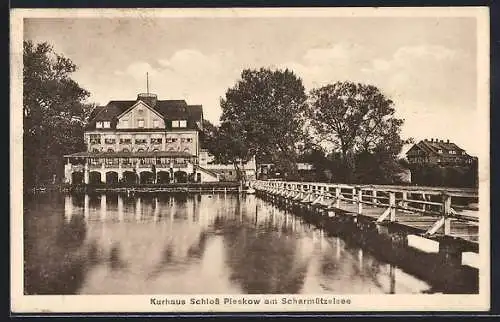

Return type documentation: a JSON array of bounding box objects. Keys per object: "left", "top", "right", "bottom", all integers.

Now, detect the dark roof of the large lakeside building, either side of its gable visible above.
[{"left": 87, "top": 95, "right": 203, "bottom": 129}]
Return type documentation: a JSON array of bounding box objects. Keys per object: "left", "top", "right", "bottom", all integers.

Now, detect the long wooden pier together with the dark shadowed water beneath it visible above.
[{"left": 251, "top": 180, "right": 480, "bottom": 293}]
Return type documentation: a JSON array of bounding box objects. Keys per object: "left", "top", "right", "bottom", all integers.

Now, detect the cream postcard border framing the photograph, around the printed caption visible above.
[{"left": 10, "top": 7, "right": 490, "bottom": 313}]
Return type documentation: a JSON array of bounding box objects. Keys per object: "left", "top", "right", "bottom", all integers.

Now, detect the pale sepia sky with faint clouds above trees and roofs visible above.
[{"left": 24, "top": 13, "right": 485, "bottom": 155}]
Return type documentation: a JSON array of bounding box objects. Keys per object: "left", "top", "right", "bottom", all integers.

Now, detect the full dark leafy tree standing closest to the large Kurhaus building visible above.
[{"left": 220, "top": 68, "right": 306, "bottom": 180}]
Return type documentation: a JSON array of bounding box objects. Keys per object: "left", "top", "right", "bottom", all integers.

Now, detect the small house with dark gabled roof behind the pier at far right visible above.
[{"left": 406, "top": 139, "right": 475, "bottom": 166}]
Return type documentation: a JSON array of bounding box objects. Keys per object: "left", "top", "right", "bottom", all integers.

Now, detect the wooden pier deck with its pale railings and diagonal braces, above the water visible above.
[{"left": 251, "top": 180, "right": 479, "bottom": 239}]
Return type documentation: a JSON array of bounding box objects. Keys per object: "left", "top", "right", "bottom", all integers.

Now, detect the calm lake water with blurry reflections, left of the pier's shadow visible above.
[{"left": 24, "top": 193, "right": 430, "bottom": 294}]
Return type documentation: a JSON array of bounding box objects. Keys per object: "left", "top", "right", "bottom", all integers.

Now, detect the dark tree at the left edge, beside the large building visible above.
[{"left": 23, "top": 41, "right": 93, "bottom": 188}]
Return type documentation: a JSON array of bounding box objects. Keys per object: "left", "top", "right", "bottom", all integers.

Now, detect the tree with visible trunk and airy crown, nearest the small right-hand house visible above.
[{"left": 309, "top": 82, "right": 411, "bottom": 181}]
